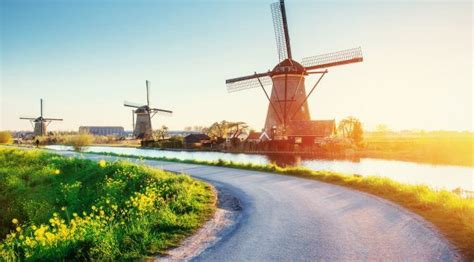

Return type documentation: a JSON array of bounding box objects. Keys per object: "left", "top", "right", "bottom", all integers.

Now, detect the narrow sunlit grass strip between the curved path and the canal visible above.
[{"left": 87, "top": 149, "right": 474, "bottom": 260}]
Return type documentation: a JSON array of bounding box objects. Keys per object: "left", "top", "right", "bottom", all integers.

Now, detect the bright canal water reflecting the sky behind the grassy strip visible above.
[{"left": 47, "top": 145, "right": 474, "bottom": 191}]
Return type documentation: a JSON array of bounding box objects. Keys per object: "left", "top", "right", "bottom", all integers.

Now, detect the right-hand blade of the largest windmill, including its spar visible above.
[{"left": 301, "top": 47, "right": 364, "bottom": 70}]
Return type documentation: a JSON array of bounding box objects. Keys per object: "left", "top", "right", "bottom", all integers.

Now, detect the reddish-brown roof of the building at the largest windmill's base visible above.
[{"left": 287, "top": 119, "right": 336, "bottom": 137}]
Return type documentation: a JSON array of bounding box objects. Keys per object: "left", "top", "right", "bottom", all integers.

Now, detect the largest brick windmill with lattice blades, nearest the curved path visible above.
[{"left": 226, "top": 0, "right": 363, "bottom": 139}]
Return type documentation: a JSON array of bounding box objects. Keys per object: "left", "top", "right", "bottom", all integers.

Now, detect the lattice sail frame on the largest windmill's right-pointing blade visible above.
[{"left": 301, "top": 47, "right": 362, "bottom": 68}]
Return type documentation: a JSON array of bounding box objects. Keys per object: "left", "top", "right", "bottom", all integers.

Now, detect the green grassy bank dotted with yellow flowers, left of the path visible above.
[{"left": 0, "top": 148, "right": 215, "bottom": 261}]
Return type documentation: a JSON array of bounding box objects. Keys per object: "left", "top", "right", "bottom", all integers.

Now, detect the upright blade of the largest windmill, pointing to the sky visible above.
[{"left": 270, "top": 0, "right": 291, "bottom": 62}]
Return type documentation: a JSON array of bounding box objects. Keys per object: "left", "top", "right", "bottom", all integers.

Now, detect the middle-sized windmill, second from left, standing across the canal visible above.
[{"left": 124, "top": 80, "right": 173, "bottom": 141}]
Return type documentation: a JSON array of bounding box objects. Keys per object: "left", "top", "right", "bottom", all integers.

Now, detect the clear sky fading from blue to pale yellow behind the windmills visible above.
[{"left": 0, "top": 0, "right": 474, "bottom": 131}]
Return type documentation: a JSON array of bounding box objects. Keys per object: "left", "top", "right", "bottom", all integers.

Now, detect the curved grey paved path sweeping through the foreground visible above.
[{"left": 55, "top": 151, "right": 460, "bottom": 261}]
